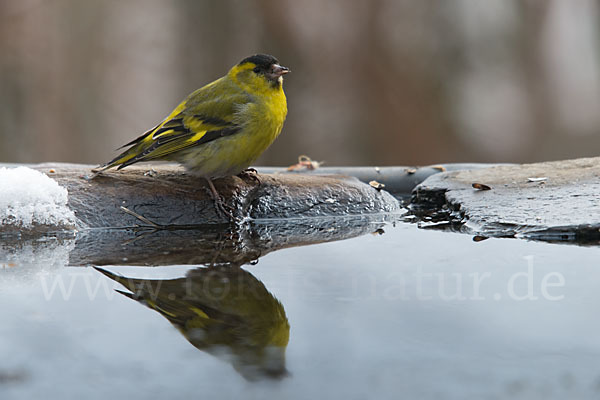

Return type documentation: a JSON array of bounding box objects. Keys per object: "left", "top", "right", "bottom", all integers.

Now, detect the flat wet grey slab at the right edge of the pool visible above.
[{"left": 411, "top": 157, "right": 600, "bottom": 245}]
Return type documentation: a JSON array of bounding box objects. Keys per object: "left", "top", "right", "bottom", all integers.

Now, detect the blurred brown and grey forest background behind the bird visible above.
[{"left": 0, "top": 0, "right": 600, "bottom": 165}]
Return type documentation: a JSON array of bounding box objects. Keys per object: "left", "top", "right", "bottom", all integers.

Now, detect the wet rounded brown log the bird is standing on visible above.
[{"left": 27, "top": 163, "right": 400, "bottom": 228}]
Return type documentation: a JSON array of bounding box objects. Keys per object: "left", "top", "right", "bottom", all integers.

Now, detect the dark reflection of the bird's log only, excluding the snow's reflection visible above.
[{"left": 69, "top": 216, "right": 384, "bottom": 265}]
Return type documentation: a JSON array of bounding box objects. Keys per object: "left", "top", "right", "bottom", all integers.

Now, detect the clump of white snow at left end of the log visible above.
[{"left": 0, "top": 167, "right": 77, "bottom": 229}]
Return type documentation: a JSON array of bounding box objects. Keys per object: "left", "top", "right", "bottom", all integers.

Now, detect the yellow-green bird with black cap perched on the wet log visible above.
[{"left": 91, "top": 54, "right": 290, "bottom": 217}]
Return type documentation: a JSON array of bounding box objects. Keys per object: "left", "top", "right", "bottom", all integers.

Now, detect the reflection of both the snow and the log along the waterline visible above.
[{"left": 0, "top": 209, "right": 396, "bottom": 268}]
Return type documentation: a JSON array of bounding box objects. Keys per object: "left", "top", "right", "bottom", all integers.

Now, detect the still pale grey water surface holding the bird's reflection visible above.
[{"left": 0, "top": 222, "right": 600, "bottom": 399}]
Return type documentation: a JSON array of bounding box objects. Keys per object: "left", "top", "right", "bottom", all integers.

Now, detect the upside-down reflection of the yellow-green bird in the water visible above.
[{"left": 96, "top": 265, "right": 290, "bottom": 381}]
